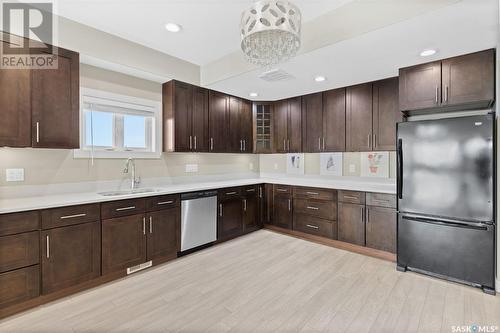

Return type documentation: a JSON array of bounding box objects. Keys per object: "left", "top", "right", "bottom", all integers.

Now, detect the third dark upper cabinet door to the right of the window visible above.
[{"left": 208, "top": 90, "right": 229, "bottom": 153}]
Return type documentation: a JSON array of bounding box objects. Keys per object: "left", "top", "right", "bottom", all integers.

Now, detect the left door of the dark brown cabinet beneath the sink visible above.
[{"left": 102, "top": 214, "right": 146, "bottom": 275}]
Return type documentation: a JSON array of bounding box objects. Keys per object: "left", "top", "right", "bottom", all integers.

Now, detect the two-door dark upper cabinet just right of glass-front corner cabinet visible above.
[{"left": 273, "top": 97, "right": 302, "bottom": 153}]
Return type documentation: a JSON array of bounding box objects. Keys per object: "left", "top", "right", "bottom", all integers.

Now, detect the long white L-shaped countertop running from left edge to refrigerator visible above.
[{"left": 0, "top": 177, "right": 396, "bottom": 214}]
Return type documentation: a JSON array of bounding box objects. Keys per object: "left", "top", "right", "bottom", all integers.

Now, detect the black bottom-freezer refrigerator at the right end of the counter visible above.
[{"left": 397, "top": 113, "right": 496, "bottom": 294}]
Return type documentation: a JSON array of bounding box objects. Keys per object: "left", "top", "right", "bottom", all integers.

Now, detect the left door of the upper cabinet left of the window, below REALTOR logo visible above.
[{"left": 0, "top": 65, "right": 31, "bottom": 147}]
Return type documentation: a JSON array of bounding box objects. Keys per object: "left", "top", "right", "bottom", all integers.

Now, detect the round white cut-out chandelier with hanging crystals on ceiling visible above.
[{"left": 240, "top": 0, "right": 301, "bottom": 67}]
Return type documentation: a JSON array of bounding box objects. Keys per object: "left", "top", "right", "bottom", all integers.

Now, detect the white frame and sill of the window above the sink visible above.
[{"left": 73, "top": 87, "right": 162, "bottom": 159}]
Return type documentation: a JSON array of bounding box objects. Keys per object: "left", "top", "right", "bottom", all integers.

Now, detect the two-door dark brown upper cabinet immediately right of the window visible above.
[{"left": 163, "top": 80, "right": 208, "bottom": 152}]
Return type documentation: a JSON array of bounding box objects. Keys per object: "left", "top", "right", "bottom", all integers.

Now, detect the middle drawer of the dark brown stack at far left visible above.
[{"left": 0, "top": 231, "right": 40, "bottom": 273}]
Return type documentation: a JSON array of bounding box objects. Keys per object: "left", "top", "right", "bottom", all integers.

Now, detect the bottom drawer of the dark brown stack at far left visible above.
[{"left": 0, "top": 265, "right": 40, "bottom": 309}]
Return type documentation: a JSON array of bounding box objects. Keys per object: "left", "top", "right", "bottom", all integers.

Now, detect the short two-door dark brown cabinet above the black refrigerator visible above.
[{"left": 399, "top": 49, "right": 495, "bottom": 111}]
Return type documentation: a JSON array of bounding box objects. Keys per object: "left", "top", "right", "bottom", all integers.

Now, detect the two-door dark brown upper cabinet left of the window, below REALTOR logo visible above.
[{"left": 0, "top": 33, "right": 80, "bottom": 149}]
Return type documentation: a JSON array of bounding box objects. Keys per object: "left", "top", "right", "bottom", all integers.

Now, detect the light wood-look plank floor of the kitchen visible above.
[{"left": 0, "top": 230, "right": 500, "bottom": 333}]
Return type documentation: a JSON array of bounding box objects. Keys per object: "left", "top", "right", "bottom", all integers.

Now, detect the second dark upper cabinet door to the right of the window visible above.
[{"left": 192, "top": 86, "right": 208, "bottom": 152}]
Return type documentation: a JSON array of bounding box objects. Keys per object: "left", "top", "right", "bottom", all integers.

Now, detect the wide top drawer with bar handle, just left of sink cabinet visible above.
[{"left": 42, "top": 204, "right": 100, "bottom": 229}]
